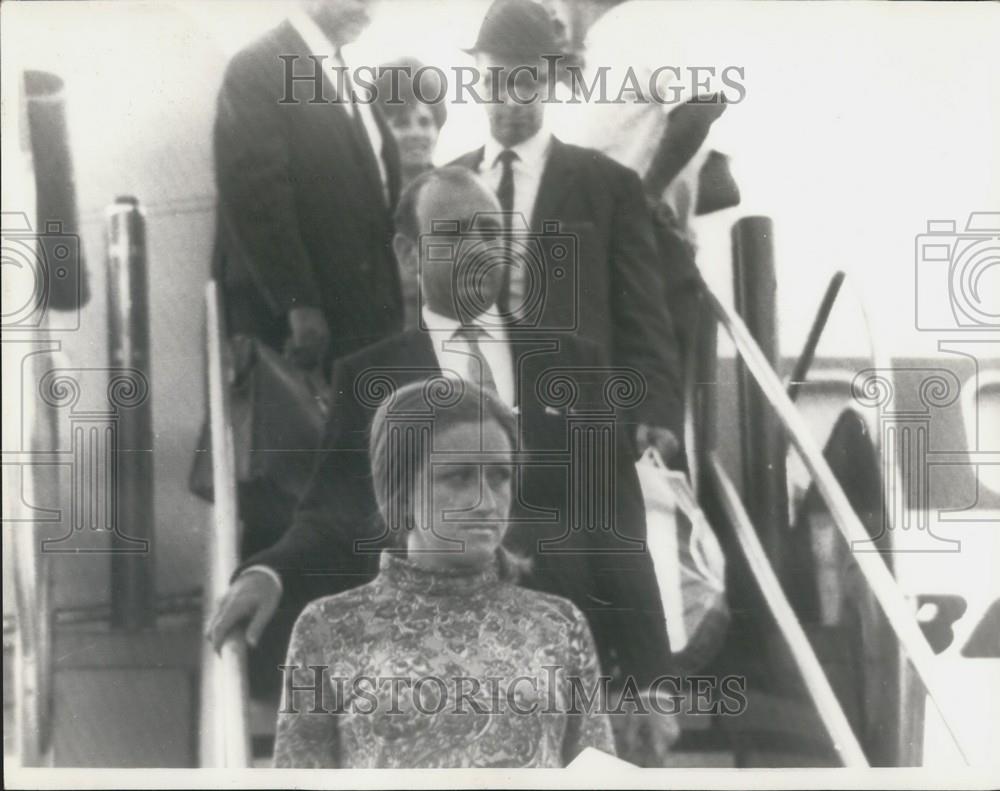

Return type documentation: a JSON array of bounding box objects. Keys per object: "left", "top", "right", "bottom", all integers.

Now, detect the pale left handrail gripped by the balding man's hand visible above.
[{"left": 201, "top": 281, "right": 250, "bottom": 768}]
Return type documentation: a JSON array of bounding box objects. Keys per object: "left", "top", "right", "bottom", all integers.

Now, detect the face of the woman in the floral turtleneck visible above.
[{"left": 407, "top": 419, "right": 513, "bottom": 568}]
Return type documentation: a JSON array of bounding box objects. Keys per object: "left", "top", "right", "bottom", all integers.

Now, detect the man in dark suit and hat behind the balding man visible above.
[{"left": 456, "top": 0, "right": 683, "bottom": 461}]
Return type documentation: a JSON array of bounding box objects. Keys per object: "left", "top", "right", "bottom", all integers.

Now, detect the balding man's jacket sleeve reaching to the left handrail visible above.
[{"left": 237, "top": 362, "right": 380, "bottom": 606}]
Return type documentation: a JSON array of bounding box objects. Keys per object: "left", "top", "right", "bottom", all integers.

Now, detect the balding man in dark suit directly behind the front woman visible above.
[{"left": 210, "top": 167, "right": 669, "bottom": 700}]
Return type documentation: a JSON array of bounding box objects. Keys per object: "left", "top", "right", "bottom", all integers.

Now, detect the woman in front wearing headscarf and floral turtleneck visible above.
[{"left": 275, "top": 379, "right": 614, "bottom": 768}]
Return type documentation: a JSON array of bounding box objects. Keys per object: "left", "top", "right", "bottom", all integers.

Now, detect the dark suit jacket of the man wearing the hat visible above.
[{"left": 455, "top": 138, "right": 683, "bottom": 438}]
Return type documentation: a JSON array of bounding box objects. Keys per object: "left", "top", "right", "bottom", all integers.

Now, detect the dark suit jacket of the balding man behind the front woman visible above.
[{"left": 244, "top": 331, "right": 669, "bottom": 683}]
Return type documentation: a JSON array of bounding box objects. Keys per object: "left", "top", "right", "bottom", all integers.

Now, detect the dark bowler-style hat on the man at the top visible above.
[{"left": 463, "top": 0, "right": 566, "bottom": 62}]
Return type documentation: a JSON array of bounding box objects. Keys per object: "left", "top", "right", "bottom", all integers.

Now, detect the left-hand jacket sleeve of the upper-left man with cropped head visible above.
[{"left": 214, "top": 50, "right": 318, "bottom": 314}]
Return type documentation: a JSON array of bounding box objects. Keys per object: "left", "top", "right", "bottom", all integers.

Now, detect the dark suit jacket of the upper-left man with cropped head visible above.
[{"left": 214, "top": 21, "right": 402, "bottom": 358}]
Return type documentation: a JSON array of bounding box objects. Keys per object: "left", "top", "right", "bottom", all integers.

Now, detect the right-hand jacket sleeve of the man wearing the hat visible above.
[{"left": 611, "top": 169, "right": 683, "bottom": 437}]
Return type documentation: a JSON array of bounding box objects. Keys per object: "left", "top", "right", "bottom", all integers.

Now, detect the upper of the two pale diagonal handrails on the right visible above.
[{"left": 704, "top": 284, "right": 969, "bottom": 764}]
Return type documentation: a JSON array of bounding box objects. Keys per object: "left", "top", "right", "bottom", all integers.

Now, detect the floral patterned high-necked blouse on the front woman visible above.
[{"left": 274, "top": 553, "right": 614, "bottom": 768}]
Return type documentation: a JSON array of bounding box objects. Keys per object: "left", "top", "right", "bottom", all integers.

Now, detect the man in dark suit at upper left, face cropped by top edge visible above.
[{"left": 213, "top": 0, "right": 403, "bottom": 695}]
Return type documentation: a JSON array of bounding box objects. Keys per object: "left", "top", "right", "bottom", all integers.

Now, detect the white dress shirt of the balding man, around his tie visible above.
[{"left": 421, "top": 305, "right": 514, "bottom": 408}]
